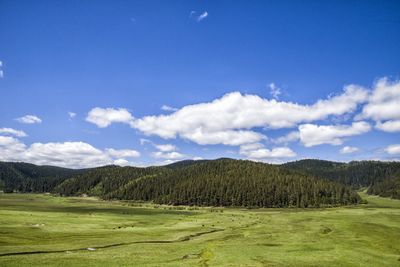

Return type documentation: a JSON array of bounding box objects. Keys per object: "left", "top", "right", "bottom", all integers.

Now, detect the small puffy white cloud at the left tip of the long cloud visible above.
[{"left": 86, "top": 107, "right": 134, "bottom": 128}]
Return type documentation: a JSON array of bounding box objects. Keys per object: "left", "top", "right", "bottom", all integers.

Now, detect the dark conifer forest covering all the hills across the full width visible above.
[{"left": 0, "top": 158, "right": 400, "bottom": 208}]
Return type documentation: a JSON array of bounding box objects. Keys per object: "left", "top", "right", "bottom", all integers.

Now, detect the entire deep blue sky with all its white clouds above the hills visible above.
[{"left": 0, "top": 0, "right": 400, "bottom": 168}]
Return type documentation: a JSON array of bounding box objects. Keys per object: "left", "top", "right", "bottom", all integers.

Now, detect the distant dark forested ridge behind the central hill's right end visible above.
[{"left": 282, "top": 159, "right": 400, "bottom": 189}]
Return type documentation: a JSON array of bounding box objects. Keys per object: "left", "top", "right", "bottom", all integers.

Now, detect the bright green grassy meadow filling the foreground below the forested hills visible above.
[{"left": 0, "top": 193, "right": 400, "bottom": 266}]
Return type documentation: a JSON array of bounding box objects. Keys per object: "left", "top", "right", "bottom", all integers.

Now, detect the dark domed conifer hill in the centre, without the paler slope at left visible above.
[{"left": 105, "top": 159, "right": 360, "bottom": 207}]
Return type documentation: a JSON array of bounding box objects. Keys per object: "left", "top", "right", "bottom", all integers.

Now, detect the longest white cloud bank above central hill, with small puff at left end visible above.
[{"left": 86, "top": 81, "right": 368, "bottom": 149}]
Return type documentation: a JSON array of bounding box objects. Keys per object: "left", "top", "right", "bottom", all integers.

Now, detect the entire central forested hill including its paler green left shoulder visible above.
[{"left": 55, "top": 159, "right": 360, "bottom": 207}]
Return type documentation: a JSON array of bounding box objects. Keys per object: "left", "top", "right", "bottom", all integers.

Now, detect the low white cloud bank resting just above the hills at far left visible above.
[{"left": 0, "top": 136, "right": 139, "bottom": 168}]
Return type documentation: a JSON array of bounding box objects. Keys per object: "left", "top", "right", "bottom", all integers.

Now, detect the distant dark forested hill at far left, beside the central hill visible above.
[{"left": 0, "top": 162, "right": 85, "bottom": 192}]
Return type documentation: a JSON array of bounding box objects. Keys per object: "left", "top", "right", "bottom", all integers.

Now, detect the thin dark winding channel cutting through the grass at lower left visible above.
[{"left": 0, "top": 229, "right": 225, "bottom": 257}]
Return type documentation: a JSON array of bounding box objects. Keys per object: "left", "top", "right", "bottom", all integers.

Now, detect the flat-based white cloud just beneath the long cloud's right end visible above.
[{"left": 299, "top": 121, "right": 371, "bottom": 147}]
